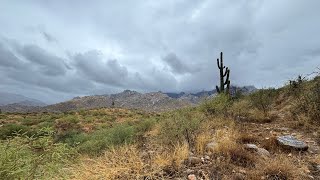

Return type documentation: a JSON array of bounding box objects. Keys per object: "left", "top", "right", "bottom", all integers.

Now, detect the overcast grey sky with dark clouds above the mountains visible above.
[{"left": 0, "top": 0, "right": 320, "bottom": 103}]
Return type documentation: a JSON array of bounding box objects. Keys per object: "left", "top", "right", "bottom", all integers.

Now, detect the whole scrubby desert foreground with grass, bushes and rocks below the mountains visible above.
[{"left": 0, "top": 77, "right": 320, "bottom": 180}]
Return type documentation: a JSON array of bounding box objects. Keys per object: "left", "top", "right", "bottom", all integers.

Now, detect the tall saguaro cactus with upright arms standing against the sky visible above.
[{"left": 216, "top": 52, "right": 230, "bottom": 94}]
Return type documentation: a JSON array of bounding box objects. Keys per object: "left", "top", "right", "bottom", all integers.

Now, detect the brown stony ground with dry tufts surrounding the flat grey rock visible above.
[{"left": 142, "top": 118, "right": 320, "bottom": 180}]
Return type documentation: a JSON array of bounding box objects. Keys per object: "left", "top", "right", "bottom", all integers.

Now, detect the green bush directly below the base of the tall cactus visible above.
[{"left": 200, "top": 94, "right": 232, "bottom": 116}]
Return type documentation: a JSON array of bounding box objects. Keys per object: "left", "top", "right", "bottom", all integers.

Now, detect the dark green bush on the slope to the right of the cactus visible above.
[{"left": 249, "top": 88, "right": 279, "bottom": 116}]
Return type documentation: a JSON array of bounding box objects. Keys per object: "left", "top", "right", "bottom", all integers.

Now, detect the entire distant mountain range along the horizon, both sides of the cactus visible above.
[{"left": 0, "top": 86, "right": 256, "bottom": 112}]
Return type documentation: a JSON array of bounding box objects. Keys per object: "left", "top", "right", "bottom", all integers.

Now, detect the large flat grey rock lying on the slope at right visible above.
[{"left": 277, "top": 135, "right": 308, "bottom": 151}]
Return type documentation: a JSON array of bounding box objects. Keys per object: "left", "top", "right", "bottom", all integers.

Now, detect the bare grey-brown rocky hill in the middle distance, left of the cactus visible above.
[{"left": 42, "top": 90, "right": 194, "bottom": 111}]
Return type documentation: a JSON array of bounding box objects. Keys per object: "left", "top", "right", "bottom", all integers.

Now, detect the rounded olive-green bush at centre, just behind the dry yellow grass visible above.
[{"left": 159, "top": 111, "right": 203, "bottom": 146}]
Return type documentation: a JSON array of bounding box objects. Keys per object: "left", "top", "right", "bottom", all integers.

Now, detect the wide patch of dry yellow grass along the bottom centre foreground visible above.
[{"left": 69, "top": 144, "right": 189, "bottom": 180}]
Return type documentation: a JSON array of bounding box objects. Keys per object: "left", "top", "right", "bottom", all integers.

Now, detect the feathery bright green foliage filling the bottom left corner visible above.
[{"left": 0, "top": 129, "right": 75, "bottom": 179}]
